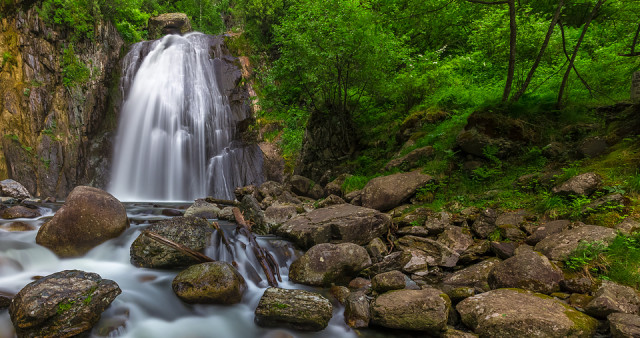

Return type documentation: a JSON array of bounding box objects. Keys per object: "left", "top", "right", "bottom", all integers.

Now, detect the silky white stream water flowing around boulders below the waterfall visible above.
[{"left": 0, "top": 204, "right": 356, "bottom": 338}]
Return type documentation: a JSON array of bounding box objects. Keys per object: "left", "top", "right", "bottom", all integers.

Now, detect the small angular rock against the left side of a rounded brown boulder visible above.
[{"left": 442, "top": 258, "right": 501, "bottom": 293}]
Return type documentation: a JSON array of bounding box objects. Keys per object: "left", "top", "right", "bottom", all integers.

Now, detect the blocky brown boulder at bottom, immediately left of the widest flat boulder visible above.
[{"left": 371, "top": 288, "right": 451, "bottom": 335}]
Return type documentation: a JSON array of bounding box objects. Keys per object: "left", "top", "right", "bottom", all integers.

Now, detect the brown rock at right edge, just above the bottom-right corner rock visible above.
[{"left": 584, "top": 281, "right": 640, "bottom": 319}]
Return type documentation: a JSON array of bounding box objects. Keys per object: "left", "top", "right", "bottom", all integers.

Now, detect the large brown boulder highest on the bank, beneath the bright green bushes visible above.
[{"left": 362, "top": 170, "right": 434, "bottom": 211}]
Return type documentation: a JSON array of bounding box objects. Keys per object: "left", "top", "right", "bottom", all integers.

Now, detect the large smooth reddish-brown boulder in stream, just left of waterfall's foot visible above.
[{"left": 36, "top": 186, "right": 129, "bottom": 257}]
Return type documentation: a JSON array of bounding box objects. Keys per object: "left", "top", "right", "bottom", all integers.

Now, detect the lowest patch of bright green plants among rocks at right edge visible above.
[{"left": 564, "top": 233, "right": 640, "bottom": 288}]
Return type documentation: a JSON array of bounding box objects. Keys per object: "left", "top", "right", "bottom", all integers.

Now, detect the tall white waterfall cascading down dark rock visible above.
[{"left": 109, "top": 33, "right": 263, "bottom": 201}]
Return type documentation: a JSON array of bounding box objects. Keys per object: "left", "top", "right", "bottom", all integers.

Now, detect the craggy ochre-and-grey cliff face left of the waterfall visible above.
[{"left": 0, "top": 4, "right": 124, "bottom": 198}]
